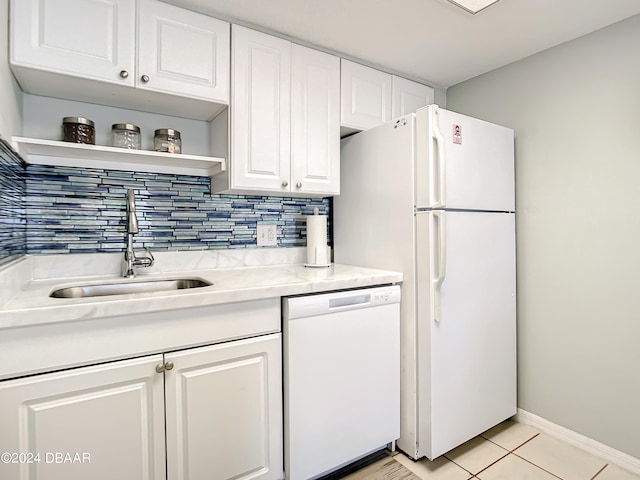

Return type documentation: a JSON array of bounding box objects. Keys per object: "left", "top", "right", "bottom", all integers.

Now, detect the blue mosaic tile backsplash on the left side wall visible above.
[{"left": 0, "top": 137, "right": 27, "bottom": 265}]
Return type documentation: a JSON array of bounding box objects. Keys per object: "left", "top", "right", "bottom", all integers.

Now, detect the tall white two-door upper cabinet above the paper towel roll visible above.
[{"left": 212, "top": 25, "right": 340, "bottom": 196}]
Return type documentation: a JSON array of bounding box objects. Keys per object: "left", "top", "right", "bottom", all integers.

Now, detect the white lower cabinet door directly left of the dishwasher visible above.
[{"left": 165, "top": 334, "right": 283, "bottom": 480}]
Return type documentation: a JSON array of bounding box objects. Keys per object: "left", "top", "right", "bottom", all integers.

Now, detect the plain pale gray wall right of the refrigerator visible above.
[{"left": 447, "top": 15, "right": 640, "bottom": 458}]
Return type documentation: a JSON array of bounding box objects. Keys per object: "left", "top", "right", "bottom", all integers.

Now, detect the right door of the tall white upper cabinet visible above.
[{"left": 291, "top": 44, "right": 340, "bottom": 195}]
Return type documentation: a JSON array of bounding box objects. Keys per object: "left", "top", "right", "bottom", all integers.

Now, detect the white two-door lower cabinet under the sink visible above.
[{"left": 0, "top": 334, "right": 283, "bottom": 480}]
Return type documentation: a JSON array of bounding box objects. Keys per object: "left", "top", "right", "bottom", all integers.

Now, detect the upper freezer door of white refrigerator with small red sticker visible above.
[{"left": 416, "top": 105, "right": 515, "bottom": 212}]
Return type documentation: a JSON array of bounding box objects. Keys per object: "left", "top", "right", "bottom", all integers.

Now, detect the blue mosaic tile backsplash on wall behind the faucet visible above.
[{"left": 23, "top": 165, "right": 330, "bottom": 254}]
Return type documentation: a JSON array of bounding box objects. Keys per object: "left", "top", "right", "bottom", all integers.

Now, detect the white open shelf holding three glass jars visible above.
[{"left": 12, "top": 137, "right": 226, "bottom": 177}]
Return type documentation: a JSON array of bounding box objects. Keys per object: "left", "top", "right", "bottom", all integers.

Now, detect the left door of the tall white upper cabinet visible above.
[{"left": 230, "top": 25, "right": 291, "bottom": 192}]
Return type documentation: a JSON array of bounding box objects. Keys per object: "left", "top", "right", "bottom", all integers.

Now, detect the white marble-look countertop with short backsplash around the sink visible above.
[{"left": 0, "top": 249, "right": 402, "bottom": 328}]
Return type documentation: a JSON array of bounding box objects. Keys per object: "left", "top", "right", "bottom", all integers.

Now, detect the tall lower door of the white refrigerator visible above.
[{"left": 416, "top": 210, "right": 516, "bottom": 459}]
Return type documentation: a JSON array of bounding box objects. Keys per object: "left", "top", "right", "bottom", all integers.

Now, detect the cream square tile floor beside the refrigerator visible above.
[{"left": 395, "top": 420, "right": 640, "bottom": 480}]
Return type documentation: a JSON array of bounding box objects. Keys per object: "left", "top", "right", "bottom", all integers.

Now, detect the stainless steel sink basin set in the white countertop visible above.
[{"left": 49, "top": 278, "right": 212, "bottom": 298}]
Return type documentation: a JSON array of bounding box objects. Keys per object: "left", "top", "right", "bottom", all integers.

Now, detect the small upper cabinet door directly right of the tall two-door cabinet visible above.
[{"left": 341, "top": 59, "right": 391, "bottom": 130}]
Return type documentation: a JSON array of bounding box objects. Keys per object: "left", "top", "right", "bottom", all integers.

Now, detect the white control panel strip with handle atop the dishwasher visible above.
[{"left": 282, "top": 285, "right": 400, "bottom": 320}]
